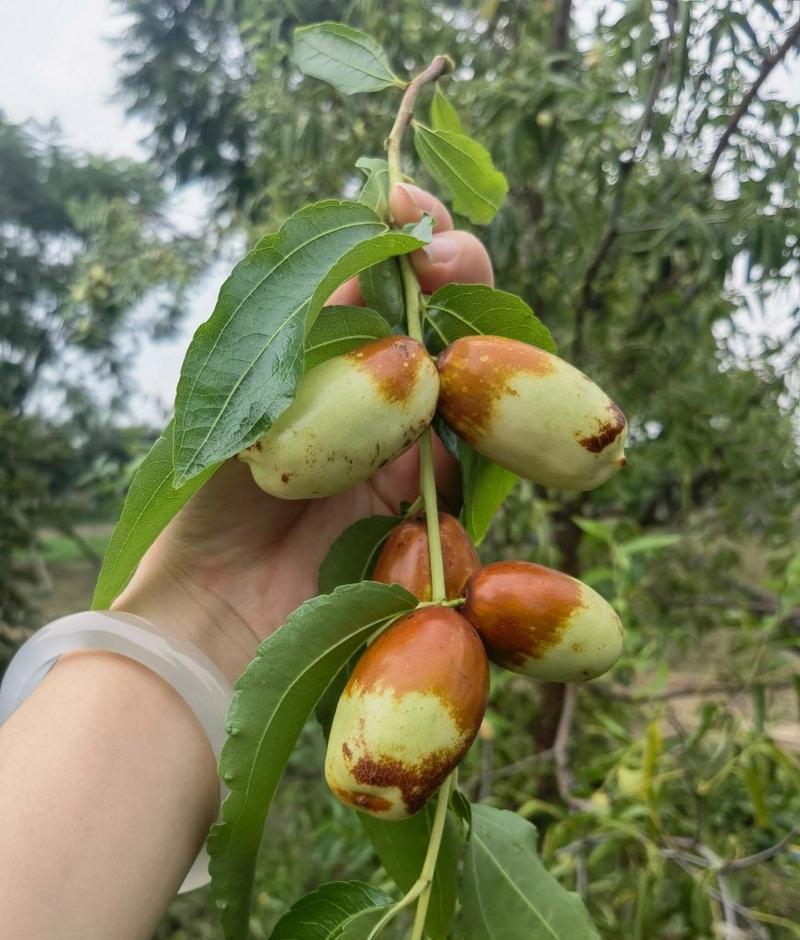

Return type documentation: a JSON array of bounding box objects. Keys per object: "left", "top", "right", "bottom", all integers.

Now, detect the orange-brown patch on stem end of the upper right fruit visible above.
[{"left": 436, "top": 336, "right": 556, "bottom": 444}]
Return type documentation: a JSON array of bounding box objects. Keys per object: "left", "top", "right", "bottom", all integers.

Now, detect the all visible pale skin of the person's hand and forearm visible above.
[{"left": 0, "top": 184, "right": 493, "bottom": 940}]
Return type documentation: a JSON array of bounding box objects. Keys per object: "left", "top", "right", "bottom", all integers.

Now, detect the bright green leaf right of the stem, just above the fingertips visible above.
[{"left": 413, "top": 121, "right": 508, "bottom": 223}]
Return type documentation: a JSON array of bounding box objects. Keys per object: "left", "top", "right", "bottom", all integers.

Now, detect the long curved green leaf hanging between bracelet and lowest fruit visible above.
[{"left": 208, "top": 581, "right": 417, "bottom": 940}]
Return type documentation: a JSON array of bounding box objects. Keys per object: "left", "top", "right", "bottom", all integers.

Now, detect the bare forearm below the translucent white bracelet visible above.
[{"left": 0, "top": 653, "right": 219, "bottom": 940}]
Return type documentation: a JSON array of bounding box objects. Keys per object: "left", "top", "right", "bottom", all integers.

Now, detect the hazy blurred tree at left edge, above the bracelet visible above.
[{"left": 0, "top": 115, "right": 202, "bottom": 636}]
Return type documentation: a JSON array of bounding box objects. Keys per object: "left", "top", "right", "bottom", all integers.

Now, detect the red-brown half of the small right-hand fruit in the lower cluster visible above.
[{"left": 461, "top": 561, "right": 583, "bottom": 669}]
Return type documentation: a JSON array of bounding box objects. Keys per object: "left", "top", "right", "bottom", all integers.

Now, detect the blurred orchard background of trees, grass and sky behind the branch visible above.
[{"left": 0, "top": 0, "right": 800, "bottom": 940}]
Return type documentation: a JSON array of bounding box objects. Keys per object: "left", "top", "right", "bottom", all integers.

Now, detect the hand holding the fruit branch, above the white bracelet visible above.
[{"left": 112, "top": 184, "right": 493, "bottom": 681}]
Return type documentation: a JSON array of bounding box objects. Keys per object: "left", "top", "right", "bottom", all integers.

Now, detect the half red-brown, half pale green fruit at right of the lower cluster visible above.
[{"left": 461, "top": 561, "right": 622, "bottom": 682}]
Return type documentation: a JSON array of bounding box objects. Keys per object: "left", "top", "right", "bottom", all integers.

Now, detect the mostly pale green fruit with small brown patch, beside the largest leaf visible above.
[{"left": 238, "top": 336, "right": 439, "bottom": 499}]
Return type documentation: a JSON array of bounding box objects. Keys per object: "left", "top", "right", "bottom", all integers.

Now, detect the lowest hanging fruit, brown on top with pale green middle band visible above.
[{"left": 325, "top": 607, "right": 489, "bottom": 819}]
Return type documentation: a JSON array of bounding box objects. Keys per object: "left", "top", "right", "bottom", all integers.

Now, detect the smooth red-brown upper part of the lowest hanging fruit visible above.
[{"left": 343, "top": 607, "right": 489, "bottom": 738}]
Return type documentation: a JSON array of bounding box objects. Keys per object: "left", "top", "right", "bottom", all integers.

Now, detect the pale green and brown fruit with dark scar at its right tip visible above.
[{"left": 437, "top": 336, "right": 627, "bottom": 490}]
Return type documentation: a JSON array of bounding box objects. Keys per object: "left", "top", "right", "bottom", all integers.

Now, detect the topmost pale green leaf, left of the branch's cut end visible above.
[{"left": 292, "top": 23, "right": 404, "bottom": 95}]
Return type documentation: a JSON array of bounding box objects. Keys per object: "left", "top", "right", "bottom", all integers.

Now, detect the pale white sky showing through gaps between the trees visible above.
[{"left": 0, "top": 0, "right": 800, "bottom": 423}]
